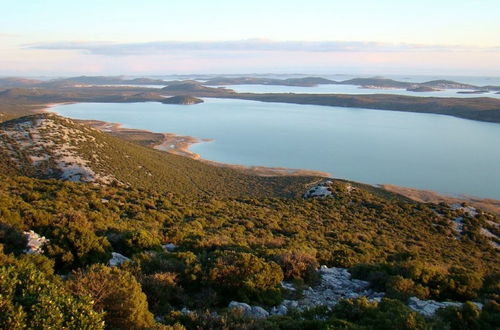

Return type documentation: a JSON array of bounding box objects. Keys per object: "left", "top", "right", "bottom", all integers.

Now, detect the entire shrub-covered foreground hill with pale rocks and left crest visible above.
[{"left": 0, "top": 114, "right": 500, "bottom": 329}]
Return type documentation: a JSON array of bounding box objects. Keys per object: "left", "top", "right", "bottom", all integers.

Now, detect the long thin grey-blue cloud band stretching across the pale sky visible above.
[{"left": 23, "top": 39, "right": 500, "bottom": 56}]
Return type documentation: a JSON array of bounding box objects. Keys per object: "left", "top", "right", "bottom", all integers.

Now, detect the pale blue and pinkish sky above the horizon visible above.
[{"left": 0, "top": 0, "right": 500, "bottom": 76}]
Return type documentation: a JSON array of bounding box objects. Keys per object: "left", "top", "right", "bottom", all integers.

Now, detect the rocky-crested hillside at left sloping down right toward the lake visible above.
[{"left": 0, "top": 114, "right": 316, "bottom": 196}]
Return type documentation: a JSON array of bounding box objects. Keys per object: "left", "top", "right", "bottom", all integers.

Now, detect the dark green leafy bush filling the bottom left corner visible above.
[{"left": 0, "top": 254, "right": 104, "bottom": 329}]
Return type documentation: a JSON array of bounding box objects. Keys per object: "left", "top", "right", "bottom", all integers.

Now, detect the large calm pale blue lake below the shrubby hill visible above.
[{"left": 54, "top": 99, "right": 500, "bottom": 199}]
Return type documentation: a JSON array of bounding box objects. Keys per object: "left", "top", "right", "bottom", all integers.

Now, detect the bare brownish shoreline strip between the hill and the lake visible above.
[{"left": 36, "top": 102, "right": 500, "bottom": 215}]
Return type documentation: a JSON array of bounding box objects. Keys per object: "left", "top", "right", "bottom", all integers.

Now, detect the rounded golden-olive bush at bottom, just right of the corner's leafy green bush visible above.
[{"left": 68, "top": 264, "right": 154, "bottom": 329}]
